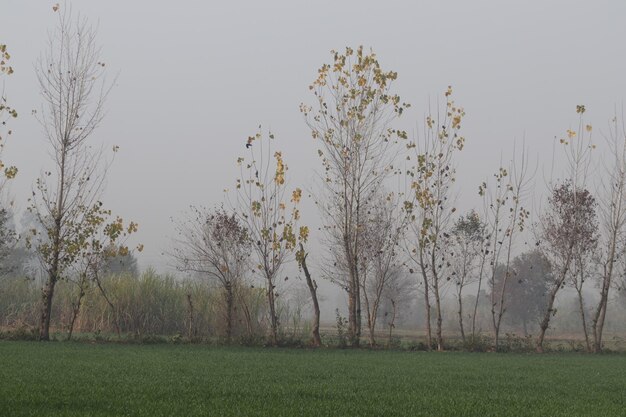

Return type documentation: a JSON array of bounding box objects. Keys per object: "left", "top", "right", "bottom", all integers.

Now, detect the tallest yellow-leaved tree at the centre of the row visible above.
[{"left": 300, "top": 46, "right": 408, "bottom": 346}]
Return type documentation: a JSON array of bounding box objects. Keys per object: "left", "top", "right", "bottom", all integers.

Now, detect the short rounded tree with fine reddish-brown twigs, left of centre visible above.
[{"left": 172, "top": 207, "right": 252, "bottom": 343}]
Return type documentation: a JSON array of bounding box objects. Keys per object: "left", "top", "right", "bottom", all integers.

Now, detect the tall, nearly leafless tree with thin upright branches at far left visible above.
[{"left": 29, "top": 5, "right": 136, "bottom": 340}]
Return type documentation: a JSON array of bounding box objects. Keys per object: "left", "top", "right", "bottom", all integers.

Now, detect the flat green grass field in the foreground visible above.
[{"left": 0, "top": 341, "right": 626, "bottom": 417}]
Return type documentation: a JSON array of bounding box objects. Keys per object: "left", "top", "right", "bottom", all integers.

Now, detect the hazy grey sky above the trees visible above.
[{"left": 0, "top": 0, "right": 626, "bottom": 276}]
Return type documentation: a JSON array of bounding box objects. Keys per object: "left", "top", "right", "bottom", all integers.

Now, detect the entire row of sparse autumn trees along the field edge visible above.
[{"left": 0, "top": 8, "right": 626, "bottom": 352}]
